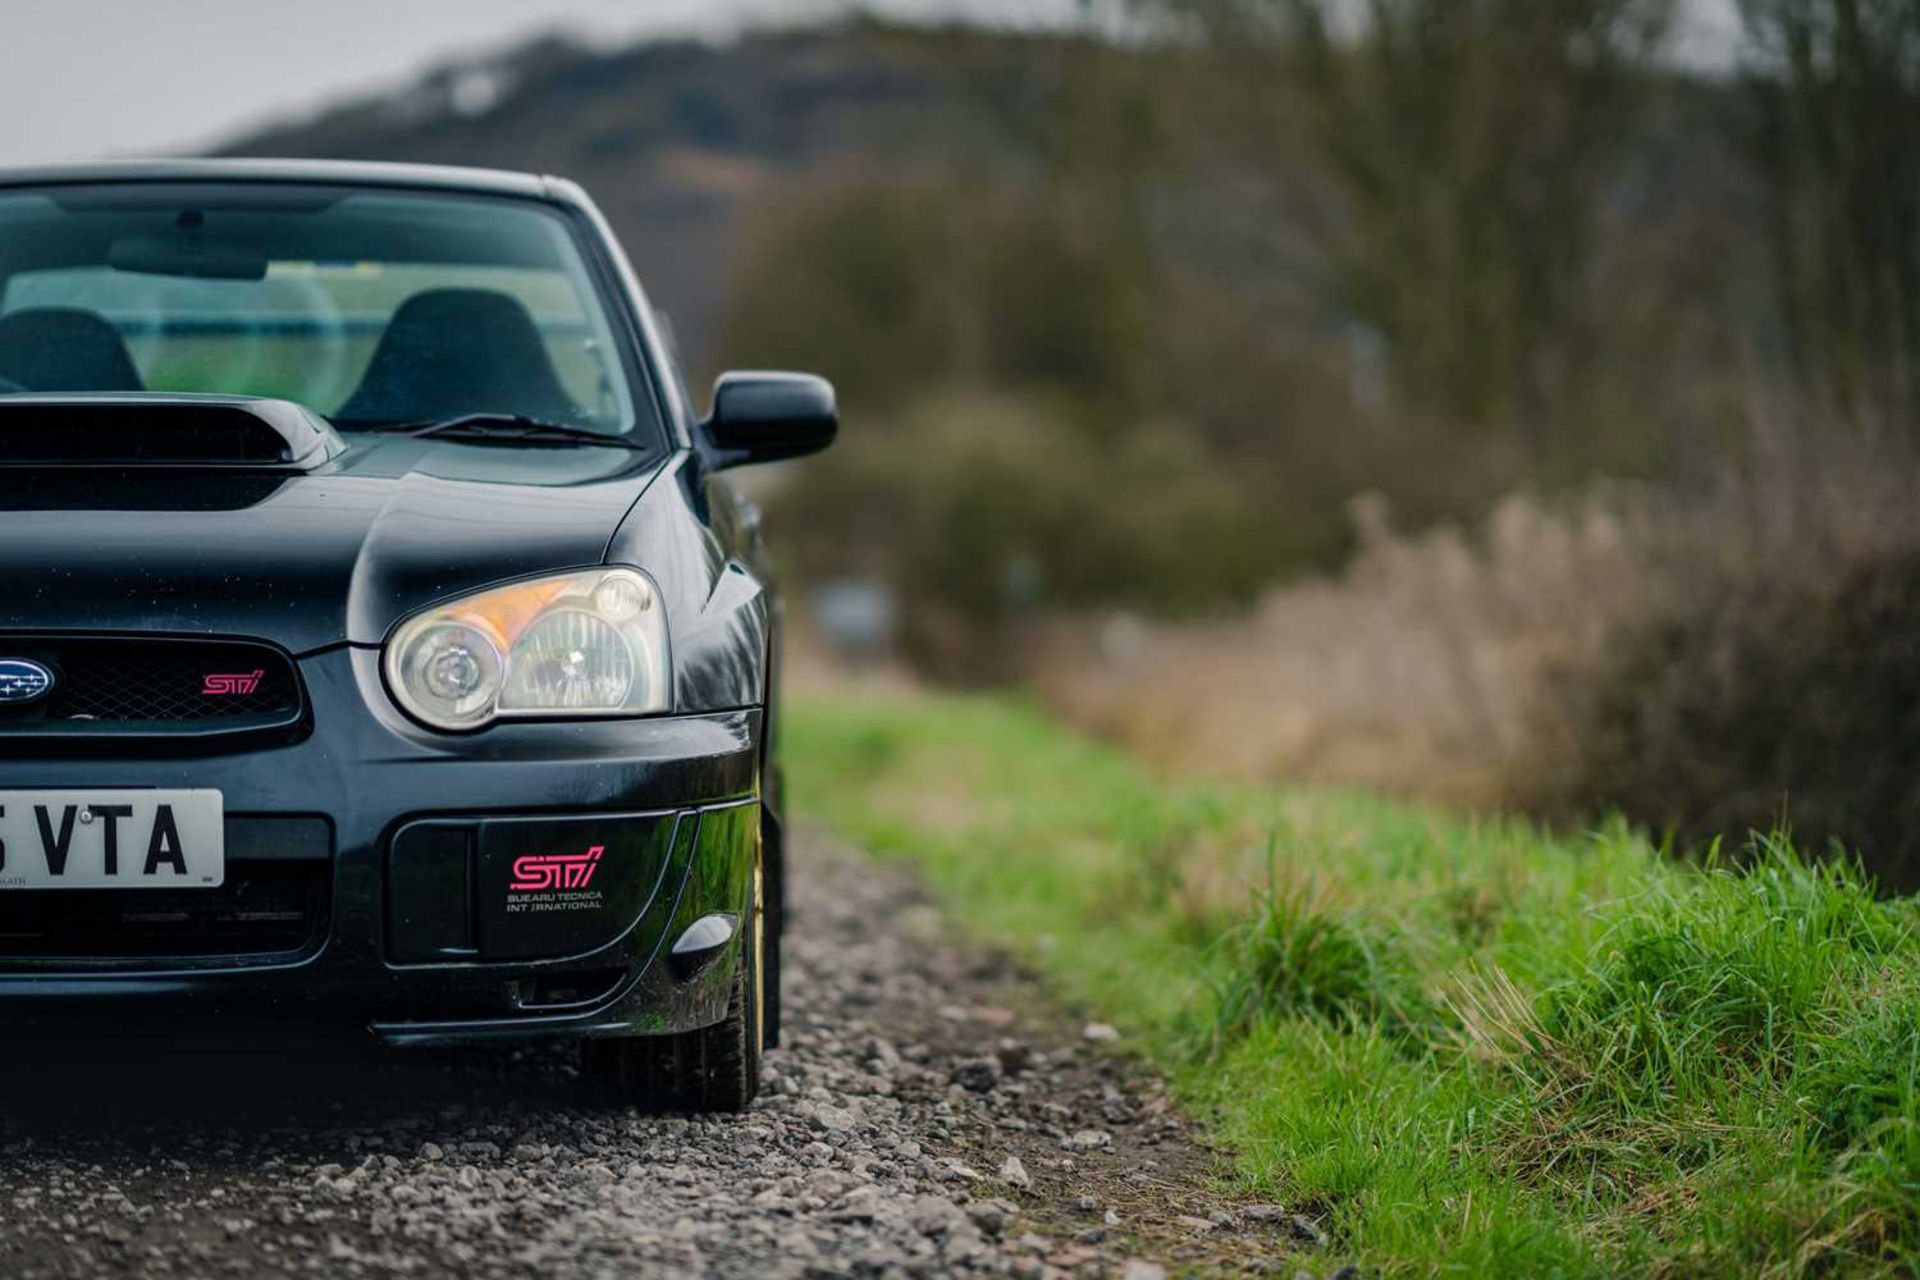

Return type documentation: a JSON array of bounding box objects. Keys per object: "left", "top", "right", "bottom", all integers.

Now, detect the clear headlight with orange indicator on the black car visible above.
[{"left": 386, "top": 568, "right": 670, "bottom": 729}]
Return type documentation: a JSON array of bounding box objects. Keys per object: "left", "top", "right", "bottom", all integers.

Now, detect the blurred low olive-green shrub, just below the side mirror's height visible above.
[{"left": 772, "top": 395, "right": 1265, "bottom": 679}]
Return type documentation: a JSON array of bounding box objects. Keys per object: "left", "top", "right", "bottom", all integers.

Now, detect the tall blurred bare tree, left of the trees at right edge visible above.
[{"left": 1171, "top": 0, "right": 1672, "bottom": 453}]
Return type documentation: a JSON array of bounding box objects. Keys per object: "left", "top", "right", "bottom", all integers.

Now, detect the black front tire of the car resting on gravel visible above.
[{"left": 580, "top": 859, "right": 768, "bottom": 1111}]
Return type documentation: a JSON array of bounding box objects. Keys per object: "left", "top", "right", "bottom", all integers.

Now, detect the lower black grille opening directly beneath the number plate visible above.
[{"left": 0, "top": 860, "right": 332, "bottom": 967}]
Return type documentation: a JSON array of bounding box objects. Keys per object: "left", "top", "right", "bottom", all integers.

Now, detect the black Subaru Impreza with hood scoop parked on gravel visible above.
[{"left": 0, "top": 161, "right": 837, "bottom": 1109}]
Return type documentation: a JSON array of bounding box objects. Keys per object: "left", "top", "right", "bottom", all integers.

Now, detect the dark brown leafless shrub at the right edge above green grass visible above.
[{"left": 1523, "top": 452, "right": 1920, "bottom": 889}]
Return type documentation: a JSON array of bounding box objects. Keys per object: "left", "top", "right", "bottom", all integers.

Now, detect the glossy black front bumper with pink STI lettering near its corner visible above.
[{"left": 0, "top": 647, "right": 762, "bottom": 1044}]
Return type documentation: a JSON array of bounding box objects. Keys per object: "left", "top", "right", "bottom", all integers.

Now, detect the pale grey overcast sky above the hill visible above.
[{"left": 0, "top": 0, "right": 1732, "bottom": 165}]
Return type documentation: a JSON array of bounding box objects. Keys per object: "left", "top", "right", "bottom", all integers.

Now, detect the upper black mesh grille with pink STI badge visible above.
[{"left": 0, "top": 637, "right": 303, "bottom": 735}]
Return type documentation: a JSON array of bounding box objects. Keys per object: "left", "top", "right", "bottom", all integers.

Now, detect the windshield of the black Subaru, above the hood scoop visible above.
[{"left": 0, "top": 182, "right": 645, "bottom": 434}]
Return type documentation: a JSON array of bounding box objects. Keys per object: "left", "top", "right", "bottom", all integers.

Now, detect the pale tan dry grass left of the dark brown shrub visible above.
[{"left": 1037, "top": 495, "right": 1644, "bottom": 802}]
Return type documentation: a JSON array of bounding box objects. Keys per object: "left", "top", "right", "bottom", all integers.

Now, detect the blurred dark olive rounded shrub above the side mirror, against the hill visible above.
[{"left": 726, "top": 171, "right": 1158, "bottom": 413}]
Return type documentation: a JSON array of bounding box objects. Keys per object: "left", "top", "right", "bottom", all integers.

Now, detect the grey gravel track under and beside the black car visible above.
[{"left": 0, "top": 833, "right": 1317, "bottom": 1280}]
